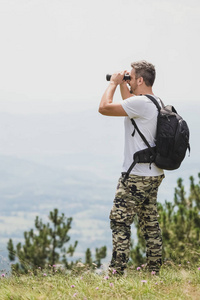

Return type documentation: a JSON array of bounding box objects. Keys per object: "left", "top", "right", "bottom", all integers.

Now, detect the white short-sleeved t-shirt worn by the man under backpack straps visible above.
[{"left": 120, "top": 95, "right": 163, "bottom": 176}]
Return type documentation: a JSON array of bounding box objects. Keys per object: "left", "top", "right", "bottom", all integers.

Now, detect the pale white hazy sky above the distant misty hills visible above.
[{"left": 0, "top": 0, "right": 200, "bottom": 113}]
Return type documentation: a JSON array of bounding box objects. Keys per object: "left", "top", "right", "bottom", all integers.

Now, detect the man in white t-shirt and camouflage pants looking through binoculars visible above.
[{"left": 99, "top": 61, "right": 164, "bottom": 274}]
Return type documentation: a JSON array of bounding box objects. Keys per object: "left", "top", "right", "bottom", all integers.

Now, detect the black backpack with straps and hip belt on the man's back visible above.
[{"left": 123, "top": 95, "right": 190, "bottom": 182}]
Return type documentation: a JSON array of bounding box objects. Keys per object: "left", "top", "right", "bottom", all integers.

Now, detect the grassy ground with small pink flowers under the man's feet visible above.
[{"left": 0, "top": 265, "right": 200, "bottom": 300}]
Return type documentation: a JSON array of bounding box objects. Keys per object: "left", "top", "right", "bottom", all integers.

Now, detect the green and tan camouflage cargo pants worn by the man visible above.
[{"left": 110, "top": 174, "right": 164, "bottom": 272}]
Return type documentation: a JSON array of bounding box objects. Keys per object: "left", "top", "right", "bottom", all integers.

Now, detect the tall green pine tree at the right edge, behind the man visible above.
[{"left": 159, "top": 173, "right": 200, "bottom": 263}]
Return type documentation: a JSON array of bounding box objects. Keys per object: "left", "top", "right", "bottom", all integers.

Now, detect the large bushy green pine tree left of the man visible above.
[{"left": 7, "top": 209, "right": 78, "bottom": 272}]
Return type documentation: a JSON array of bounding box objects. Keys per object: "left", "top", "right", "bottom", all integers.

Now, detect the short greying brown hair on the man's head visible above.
[{"left": 131, "top": 60, "right": 156, "bottom": 86}]
